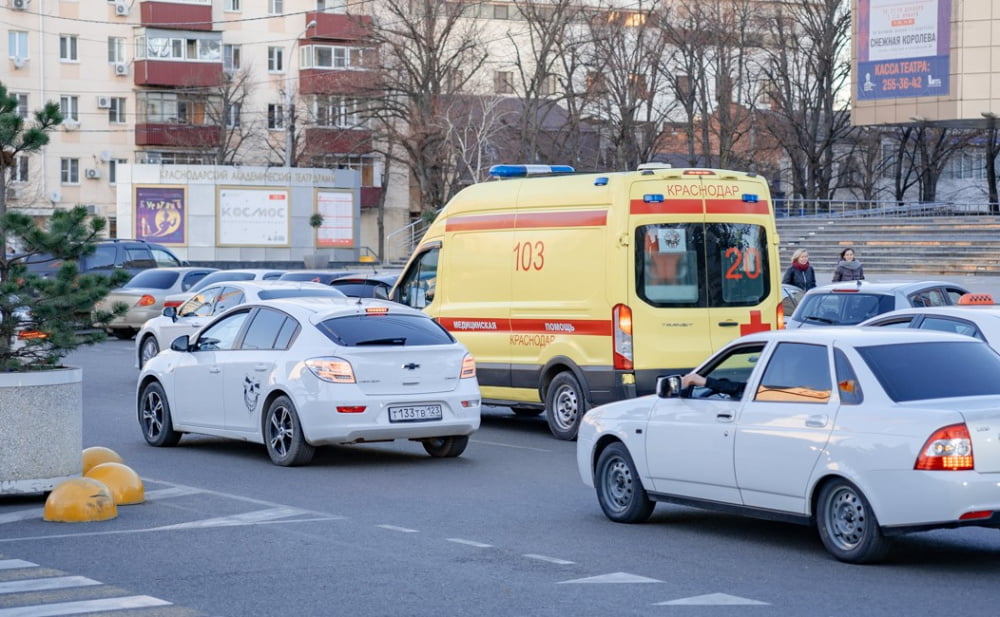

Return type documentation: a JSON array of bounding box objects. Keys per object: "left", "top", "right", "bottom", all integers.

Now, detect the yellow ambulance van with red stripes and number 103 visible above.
[{"left": 391, "top": 165, "right": 784, "bottom": 439}]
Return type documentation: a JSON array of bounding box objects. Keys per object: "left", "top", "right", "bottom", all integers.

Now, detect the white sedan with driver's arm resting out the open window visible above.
[{"left": 577, "top": 327, "right": 1000, "bottom": 563}]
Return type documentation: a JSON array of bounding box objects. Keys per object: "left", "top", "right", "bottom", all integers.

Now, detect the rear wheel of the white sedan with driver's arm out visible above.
[{"left": 816, "top": 479, "right": 890, "bottom": 563}]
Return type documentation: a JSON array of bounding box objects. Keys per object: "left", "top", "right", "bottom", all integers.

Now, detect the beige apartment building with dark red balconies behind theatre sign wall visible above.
[{"left": 0, "top": 0, "right": 410, "bottom": 258}]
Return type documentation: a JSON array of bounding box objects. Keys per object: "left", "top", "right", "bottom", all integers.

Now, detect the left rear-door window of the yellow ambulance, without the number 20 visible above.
[{"left": 635, "top": 223, "right": 704, "bottom": 306}]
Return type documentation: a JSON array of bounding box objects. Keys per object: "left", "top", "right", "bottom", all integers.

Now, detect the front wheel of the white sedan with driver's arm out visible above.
[{"left": 594, "top": 442, "right": 656, "bottom": 523}]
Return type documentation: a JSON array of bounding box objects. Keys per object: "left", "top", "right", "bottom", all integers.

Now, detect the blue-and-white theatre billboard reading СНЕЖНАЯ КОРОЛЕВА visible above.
[{"left": 855, "top": 0, "right": 951, "bottom": 101}]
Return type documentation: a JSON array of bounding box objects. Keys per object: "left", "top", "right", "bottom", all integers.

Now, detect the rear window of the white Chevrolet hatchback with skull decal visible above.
[{"left": 317, "top": 314, "right": 455, "bottom": 347}]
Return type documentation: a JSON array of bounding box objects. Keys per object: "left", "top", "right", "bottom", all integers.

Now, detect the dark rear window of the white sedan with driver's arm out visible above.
[{"left": 858, "top": 340, "right": 1000, "bottom": 403}]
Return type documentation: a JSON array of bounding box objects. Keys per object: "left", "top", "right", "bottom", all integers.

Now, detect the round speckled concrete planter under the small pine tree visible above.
[{"left": 0, "top": 368, "right": 83, "bottom": 495}]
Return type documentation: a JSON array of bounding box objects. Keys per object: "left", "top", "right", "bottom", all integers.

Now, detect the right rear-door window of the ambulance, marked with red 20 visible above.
[{"left": 705, "top": 223, "right": 771, "bottom": 306}]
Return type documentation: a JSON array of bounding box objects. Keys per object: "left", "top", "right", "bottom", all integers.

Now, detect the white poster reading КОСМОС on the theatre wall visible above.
[{"left": 216, "top": 186, "right": 291, "bottom": 247}]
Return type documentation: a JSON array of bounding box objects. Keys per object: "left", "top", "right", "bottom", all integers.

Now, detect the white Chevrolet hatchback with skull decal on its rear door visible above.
[{"left": 136, "top": 297, "right": 480, "bottom": 466}]
